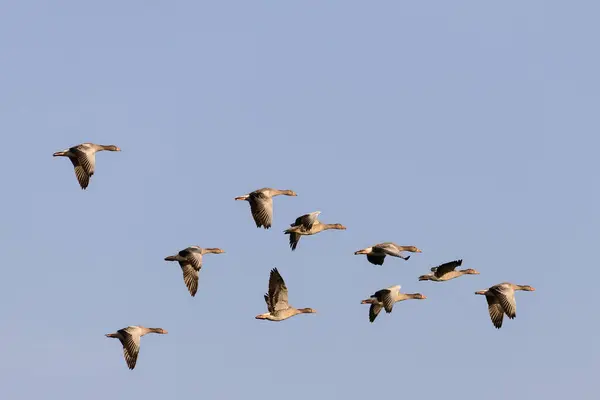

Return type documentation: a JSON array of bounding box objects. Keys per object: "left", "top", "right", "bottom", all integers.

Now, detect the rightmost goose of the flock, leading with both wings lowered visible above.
[{"left": 475, "top": 282, "right": 535, "bottom": 329}]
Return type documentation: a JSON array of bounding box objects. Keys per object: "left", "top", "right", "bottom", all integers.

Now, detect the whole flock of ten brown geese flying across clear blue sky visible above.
[{"left": 54, "top": 143, "right": 535, "bottom": 369}]
